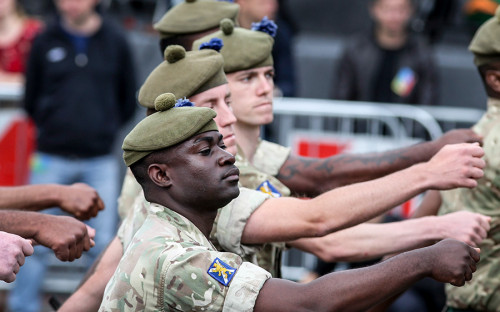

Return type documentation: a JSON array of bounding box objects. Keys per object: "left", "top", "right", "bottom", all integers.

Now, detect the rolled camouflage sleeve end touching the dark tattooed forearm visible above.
[{"left": 253, "top": 140, "right": 291, "bottom": 176}]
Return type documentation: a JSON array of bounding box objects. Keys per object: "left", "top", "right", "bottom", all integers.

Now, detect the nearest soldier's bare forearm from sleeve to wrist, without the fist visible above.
[{"left": 255, "top": 254, "right": 426, "bottom": 311}]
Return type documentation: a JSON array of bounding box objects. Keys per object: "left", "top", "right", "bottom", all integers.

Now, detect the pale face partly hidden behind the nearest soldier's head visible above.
[{"left": 189, "top": 84, "right": 237, "bottom": 155}]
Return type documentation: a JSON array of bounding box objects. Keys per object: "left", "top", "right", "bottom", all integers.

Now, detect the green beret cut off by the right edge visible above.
[{"left": 469, "top": 7, "right": 500, "bottom": 66}]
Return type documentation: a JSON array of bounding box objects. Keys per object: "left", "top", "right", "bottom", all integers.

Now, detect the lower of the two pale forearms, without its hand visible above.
[{"left": 288, "top": 217, "right": 443, "bottom": 262}]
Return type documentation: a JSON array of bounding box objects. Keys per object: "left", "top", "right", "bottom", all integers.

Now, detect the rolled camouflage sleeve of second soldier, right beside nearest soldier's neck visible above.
[{"left": 215, "top": 188, "right": 269, "bottom": 262}]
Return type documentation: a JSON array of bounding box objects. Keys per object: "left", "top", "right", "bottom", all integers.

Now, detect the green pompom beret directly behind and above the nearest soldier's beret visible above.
[{"left": 138, "top": 45, "right": 227, "bottom": 108}]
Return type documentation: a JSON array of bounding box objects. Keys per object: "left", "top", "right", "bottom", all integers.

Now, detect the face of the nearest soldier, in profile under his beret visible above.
[{"left": 168, "top": 131, "right": 239, "bottom": 209}]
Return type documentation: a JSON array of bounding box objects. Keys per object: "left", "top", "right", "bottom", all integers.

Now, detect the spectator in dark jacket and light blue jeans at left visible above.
[{"left": 9, "top": 0, "right": 136, "bottom": 311}]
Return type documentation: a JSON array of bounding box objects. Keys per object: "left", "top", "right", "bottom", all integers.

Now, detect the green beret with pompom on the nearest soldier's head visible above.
[{"left": 122, "top": 93, "right": 217, "bottom": 166}]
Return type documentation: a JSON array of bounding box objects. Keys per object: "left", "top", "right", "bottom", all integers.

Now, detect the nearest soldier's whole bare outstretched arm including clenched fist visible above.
[{"left": 254, "top": 240, "right": 479, "bottom": 311}]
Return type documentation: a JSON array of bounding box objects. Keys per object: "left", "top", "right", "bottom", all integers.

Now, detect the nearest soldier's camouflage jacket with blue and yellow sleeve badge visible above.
[{"left": 99, "top": 204, "right": 270, "bottom": 311}]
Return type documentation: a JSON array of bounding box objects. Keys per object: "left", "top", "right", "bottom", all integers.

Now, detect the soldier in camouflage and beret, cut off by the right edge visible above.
[{"left": 439, "top": 9, "right": 500, "bottom": 312}]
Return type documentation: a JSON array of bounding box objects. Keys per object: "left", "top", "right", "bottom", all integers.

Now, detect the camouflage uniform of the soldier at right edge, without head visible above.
[{"left": 439, "top": 98, "right": 500, "bottom": 311}]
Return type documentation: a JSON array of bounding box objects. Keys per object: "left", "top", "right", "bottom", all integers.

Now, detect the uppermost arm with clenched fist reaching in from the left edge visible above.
[{"left": 0, "top": 183, "right": 104, "bottom": 220}]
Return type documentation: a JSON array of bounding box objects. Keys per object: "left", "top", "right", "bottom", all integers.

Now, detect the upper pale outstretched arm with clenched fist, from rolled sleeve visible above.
[{"left": 241, "top": 143, "right": 485, "bottom": 244}]
